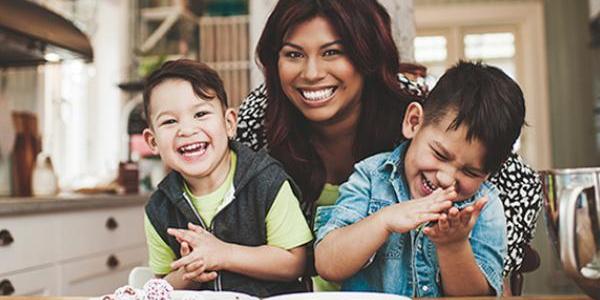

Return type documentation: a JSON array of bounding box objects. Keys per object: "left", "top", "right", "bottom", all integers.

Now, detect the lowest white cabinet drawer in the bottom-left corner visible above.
[{"left": 0, "top": 267, "right": 59, "bottom": 296}]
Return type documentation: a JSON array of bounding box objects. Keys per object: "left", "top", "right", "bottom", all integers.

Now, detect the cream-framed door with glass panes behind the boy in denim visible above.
[{"left": 414, "top": 0, "right": 551, "bottom": 169}]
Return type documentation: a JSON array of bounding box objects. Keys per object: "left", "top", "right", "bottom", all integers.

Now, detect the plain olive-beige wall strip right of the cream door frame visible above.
[{"left": 545, "top": 0, "right": 600, "bottom": 168}]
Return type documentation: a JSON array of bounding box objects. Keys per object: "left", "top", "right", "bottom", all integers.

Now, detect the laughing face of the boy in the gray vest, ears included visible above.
[{"left": 144, "top": 79, "right": 237, "bottom": 189}]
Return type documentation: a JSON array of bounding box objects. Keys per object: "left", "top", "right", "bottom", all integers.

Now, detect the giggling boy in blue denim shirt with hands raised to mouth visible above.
[{"left": 315, "top": 62, "right": 525, "bottom": 297}]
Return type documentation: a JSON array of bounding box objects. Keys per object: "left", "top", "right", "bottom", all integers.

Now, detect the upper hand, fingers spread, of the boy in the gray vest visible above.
[{"left": 167, "top": 223, "right": 229, "bottom": 282}]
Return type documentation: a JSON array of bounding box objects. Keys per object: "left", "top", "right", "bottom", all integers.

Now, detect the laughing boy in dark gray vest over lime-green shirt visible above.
[{"left": 143, "top": 60, "right": 312, "bottom": 298}]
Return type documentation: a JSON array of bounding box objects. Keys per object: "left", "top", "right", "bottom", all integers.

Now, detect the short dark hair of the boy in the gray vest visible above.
[{"left": 144, "top": 59, "right": 227, "bottom": 126}]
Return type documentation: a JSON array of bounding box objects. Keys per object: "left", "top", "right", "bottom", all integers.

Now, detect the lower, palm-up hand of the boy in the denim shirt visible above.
[{"left": 423, "top": 196, "right": 488, "bottom": 248}]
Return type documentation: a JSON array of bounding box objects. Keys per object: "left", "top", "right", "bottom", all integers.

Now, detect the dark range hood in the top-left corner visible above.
[{"left": 0, "top": 0, "right": 94, "bottom": 67}]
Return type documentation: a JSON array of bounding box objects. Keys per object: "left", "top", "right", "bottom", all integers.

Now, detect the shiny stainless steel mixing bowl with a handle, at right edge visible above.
[{"left": 541, "top": 168, "right": 600, "bottom": 299}]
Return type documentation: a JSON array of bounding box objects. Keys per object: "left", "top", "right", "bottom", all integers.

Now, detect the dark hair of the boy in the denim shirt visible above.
[{"left": 423, "top": 61, "right": 525, "bottom": 173}]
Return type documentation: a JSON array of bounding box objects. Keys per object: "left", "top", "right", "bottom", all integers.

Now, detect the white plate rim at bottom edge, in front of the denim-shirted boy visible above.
[{"left": 266, "top": 292, "right": 410, "bottom": 300}]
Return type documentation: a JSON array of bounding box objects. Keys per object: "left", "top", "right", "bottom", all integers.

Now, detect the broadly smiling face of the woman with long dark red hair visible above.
[{"left": 278, "top": 17, "right": 364, "bottom": 125}]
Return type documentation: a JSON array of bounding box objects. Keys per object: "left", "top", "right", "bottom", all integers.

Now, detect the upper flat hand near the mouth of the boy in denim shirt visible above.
[{"left": 381, "top": 186, "right": 457, "bottom": 233}]
